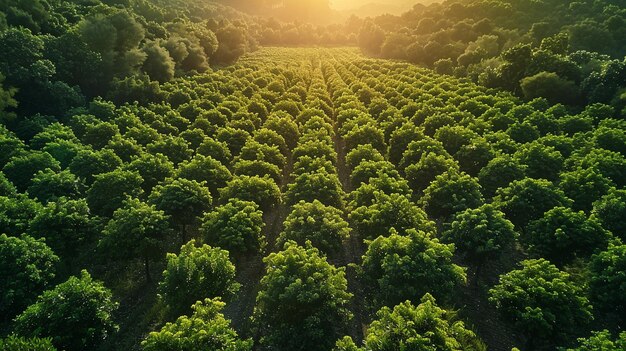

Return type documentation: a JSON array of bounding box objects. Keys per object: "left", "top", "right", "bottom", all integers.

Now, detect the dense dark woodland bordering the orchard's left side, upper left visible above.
[{"left": 0, "top": 0, "right": 256, "bottom": 118}]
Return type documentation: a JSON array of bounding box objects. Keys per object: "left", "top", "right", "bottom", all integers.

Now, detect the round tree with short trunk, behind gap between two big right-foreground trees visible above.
[{"left": 441, "top": 204, "right": 517, "bottom": 272}]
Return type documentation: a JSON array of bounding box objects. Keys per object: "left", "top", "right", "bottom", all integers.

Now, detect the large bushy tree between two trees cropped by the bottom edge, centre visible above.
[{"left": 253, "top": 242, "right": 352, "bottom": 351}]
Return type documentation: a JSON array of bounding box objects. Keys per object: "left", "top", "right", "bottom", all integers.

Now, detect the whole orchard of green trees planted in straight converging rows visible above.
[{"left": 0, "top": 44, "right": 626, "bottom": 350}]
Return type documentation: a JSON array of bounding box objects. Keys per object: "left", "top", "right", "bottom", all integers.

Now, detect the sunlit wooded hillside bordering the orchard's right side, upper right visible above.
[{"left": 359, "top": 0, "right": 626, "bottom": 111}]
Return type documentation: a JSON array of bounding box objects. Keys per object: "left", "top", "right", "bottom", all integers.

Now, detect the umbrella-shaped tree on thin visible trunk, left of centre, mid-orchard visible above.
[{"left": 148, "top": 178, "right": 213, "bottom": 243}]
